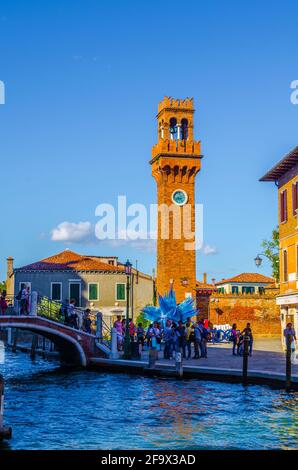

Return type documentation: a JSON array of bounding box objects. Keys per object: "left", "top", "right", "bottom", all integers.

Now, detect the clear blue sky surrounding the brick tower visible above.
[{"left": 0, "top": 0, "right": 298, "bottom": 279}]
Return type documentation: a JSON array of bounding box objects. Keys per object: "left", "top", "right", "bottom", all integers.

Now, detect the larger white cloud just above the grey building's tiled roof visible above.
[{"left": 51, "top": 222, "right": 94, "bottom": 243}]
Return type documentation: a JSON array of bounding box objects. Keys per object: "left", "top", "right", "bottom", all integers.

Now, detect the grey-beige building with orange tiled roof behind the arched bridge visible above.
[{"left": 7, "top": 250, "right": 154, "bottom": 323}]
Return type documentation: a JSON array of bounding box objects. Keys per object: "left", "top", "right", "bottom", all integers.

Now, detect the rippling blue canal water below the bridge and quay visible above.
[{"left": 0, "top": 351, "right": 298, "bottom": 449}]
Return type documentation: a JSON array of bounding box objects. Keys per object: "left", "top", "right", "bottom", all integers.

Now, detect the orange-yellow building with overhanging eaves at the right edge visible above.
[{"left": 260, "top": 147, "right": 298, "bottom": 342}]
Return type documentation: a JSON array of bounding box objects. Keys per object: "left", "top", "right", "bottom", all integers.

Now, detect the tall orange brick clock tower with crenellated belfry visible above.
[{"left": 150, "top": 97, "right": 202, "bottom": 302}]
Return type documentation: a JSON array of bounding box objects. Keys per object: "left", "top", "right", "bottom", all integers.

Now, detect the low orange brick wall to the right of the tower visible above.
[{"left": 210, "top": 290, "right": 281, "bottom": 337}]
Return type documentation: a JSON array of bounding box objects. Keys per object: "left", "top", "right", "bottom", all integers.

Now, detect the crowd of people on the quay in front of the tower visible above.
[{"left": 113, "top": 316, "right": 212, "bottom": 359}]
